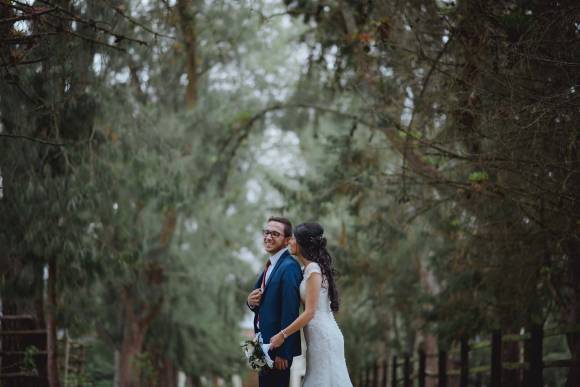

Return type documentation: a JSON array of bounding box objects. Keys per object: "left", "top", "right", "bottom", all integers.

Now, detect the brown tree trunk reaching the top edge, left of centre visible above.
[{"left": 177, "top": 0, "right": 197, "bottom": 108}]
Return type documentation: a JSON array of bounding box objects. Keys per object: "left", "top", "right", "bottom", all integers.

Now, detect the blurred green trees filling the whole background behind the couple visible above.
[{"left": 0, "top": 0, "right": 580, "bottom": 386}]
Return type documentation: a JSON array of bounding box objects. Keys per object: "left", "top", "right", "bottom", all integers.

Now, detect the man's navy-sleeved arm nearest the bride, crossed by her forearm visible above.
[{"left": 276, "top": 264, "right": 302, "bottom": 360}]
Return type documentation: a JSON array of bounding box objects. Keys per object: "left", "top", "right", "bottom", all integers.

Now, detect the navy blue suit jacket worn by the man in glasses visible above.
[{"left": 250, "top": 251, "right": 302, "bottom": 364}]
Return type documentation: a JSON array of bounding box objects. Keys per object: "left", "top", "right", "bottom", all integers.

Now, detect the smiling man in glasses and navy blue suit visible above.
[{"left": 248, "top": 217, "right": 302, "bottom": 387}]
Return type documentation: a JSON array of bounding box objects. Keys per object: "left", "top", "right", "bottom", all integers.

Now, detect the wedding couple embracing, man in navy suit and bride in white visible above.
[{"left": 248, "top": 217, "right": 352, "bottom": 387}]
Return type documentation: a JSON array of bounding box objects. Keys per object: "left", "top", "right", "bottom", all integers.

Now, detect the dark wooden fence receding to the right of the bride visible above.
[{"left": 355, "top": 326, "right": 580, "bottom": 387}]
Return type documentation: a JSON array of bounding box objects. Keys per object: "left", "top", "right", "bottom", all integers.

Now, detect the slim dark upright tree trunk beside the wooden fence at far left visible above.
[{"left": 45, "top": 257, "right": 60, "bottom": 387}]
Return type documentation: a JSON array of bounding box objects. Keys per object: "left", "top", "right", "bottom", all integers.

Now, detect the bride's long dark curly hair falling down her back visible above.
[{"left": 294, "top": 223, "right": 339, "bottom": 312}]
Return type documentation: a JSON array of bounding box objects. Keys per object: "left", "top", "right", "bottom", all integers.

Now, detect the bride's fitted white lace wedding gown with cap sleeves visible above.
[{"left": 300, "top": 262, "right": 352, "bottom": 387}]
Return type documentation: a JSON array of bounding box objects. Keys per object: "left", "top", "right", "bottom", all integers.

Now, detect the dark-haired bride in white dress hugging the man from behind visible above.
[{"left": 270, "top": 223, "right": 352, "bottom": 387}]
